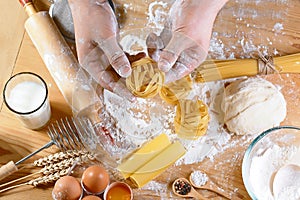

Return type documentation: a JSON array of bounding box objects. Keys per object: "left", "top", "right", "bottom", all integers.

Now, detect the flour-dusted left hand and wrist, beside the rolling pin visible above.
[{"left": 69, "top": 0, "right": 131, "bottom": 98}]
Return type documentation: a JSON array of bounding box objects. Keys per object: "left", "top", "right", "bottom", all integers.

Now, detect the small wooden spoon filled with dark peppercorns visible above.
[{"left": 172, "top": 178, "right": 208, "bottom": 200}]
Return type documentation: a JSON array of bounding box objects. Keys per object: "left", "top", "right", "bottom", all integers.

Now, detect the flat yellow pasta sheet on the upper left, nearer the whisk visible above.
[{"left": 118, "top": 133, "right": 171, "bottom": 179}]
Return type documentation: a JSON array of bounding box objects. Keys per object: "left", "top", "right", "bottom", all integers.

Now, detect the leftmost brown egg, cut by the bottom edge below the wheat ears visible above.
[{"left": 52, "top": 176, "right": 82, "bottom": 200}]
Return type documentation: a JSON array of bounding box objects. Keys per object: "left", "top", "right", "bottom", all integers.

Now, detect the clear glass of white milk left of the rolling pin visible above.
[{"left": 3, "top": 72, "right": 51, "bottom": 129}]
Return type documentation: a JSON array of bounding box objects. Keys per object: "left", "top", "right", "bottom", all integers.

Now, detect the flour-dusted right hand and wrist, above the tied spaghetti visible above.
[{"left": 147, "top": 0, "right": 228, "bottom": 83}]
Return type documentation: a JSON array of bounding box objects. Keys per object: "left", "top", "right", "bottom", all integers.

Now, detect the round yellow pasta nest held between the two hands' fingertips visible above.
[{"left": 126, "top": 57, "right": 165, "bottom": 98}]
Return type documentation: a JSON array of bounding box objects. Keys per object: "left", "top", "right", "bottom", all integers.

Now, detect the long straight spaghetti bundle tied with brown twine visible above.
[{"left": 193, "top": 53, "right": 300, "bottom": 82}]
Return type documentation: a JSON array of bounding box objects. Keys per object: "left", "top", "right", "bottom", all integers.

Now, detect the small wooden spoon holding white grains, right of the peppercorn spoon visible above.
[{"left": 189, "top": 170, "right": 231, "bottom": 199}]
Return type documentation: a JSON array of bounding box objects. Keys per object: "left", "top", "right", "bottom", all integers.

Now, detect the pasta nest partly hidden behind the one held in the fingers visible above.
[{"left": 159, "top": 75, "right": 193, "bottom": 105}]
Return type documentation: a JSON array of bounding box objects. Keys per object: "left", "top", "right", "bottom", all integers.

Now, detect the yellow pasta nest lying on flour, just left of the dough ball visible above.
[{"left": 174, "top": 99, "right": 209, "bottom": 140}]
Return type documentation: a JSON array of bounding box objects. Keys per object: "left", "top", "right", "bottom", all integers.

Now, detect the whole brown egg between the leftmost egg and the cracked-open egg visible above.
[{"left": 81, "top": 165, "right": 109, "bottom": 194}]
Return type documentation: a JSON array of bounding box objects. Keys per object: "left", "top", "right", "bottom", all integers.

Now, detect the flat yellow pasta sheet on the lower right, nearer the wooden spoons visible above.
[{"left": 130, "top": 141, "right": 186, "bottom": 187}]
